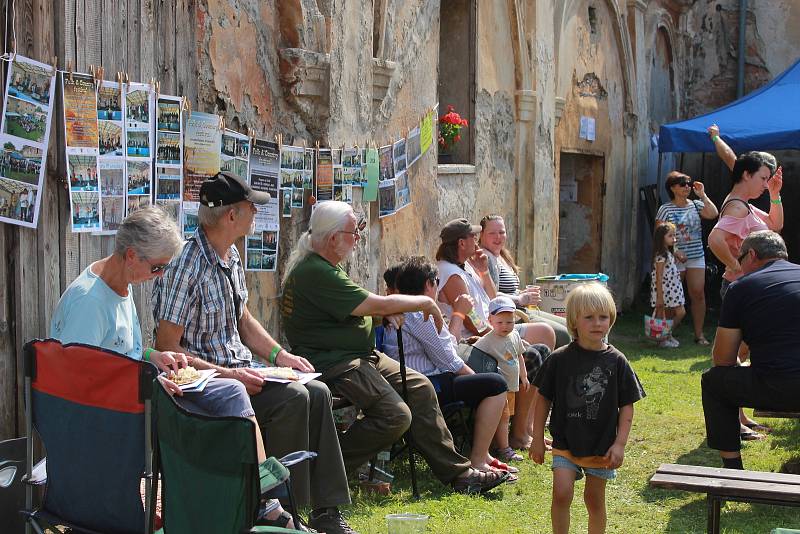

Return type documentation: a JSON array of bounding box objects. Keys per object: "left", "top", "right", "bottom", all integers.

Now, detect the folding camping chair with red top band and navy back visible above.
[{"left": 22, "top": 339, "right": 157, "bottom": 534}]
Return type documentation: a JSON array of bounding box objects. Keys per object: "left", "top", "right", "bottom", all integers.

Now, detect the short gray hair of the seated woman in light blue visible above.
[{"left": 114, "top": 206, "right": 183, "bottom": 258}]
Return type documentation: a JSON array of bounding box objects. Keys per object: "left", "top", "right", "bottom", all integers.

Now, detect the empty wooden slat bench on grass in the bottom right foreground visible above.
[{"left": 650, "top": 464, "right": 800, "bottom": 534}]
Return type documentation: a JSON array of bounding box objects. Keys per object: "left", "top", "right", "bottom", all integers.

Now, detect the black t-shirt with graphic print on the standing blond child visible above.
[{"left": 534, "top": 341, "right": 645, "bottom": 457}]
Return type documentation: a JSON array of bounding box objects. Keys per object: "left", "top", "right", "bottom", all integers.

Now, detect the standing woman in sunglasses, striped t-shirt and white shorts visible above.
[{"left": 656, "top": 171, "right": 718, "bottom": 345}]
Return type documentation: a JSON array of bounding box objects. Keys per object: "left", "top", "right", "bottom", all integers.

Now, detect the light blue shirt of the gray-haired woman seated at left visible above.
[{"left": 50, "top": 265, "right": 142, "bottom": 360}]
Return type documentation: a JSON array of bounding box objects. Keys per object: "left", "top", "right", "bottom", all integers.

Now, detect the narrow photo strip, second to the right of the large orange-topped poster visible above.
[{"left": 123, "top": 83, "right": 154, "bottom": 215}]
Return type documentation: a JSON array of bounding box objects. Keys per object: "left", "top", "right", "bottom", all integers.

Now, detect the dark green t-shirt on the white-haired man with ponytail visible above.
[{"left": 281, "top": 253, "right": 375, "bottom": 372}]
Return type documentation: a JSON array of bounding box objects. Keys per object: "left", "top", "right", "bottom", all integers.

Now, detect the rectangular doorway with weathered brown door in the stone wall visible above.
[{"left": 558, "top": 151, "right": 605, "bottom": 273}]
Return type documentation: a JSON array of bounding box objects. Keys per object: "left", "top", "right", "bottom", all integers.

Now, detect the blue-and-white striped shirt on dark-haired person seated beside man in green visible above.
[{"left": 383, "top": 312, "right": 464, "bottom": 376}]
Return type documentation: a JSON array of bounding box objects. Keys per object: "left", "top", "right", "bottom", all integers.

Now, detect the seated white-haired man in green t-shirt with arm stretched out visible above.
[{"left": 281, "top": 201, "right": 507, "bottom": 493}]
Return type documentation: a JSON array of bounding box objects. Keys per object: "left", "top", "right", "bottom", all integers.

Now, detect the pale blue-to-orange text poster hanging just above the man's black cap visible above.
[{"left": 182, "top": 111, "right": 222, "bottom": 238}]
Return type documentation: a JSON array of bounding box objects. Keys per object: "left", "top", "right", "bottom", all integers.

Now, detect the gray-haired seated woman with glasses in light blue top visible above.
[{"left": 50, "top": 207, "right": 304, "bottom": 526}]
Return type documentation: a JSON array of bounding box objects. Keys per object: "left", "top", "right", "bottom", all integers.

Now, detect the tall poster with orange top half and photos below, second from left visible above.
[{"left": 61, "top": 73, "right": 102, "bottom": 232}]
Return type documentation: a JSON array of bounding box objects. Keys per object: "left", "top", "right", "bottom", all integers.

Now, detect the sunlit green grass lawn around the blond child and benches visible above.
[{"left": 346, "top": 311, "right": 800, "bottom": 534}]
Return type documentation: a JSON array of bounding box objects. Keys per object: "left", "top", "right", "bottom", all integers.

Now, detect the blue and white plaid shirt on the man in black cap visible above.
[{"left": 153, "top": 227, "right": 253, "bottom": 367}]
